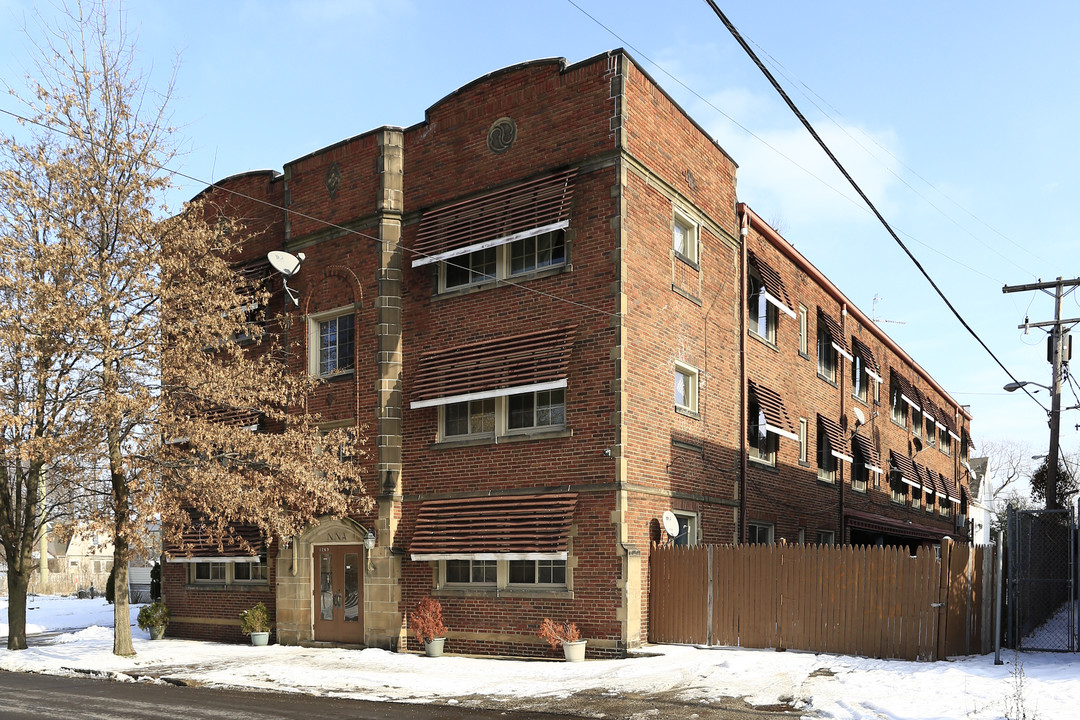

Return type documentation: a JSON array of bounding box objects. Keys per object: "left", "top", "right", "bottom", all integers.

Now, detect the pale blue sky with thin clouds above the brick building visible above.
[{"left": 0, "top": 0, "right": 1080, "bottom": 479}]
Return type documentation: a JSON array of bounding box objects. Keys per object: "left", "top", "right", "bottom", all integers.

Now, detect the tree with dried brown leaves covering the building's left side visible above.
[{"left": 0, "top": 4, "right": 370, "bottom": 655}]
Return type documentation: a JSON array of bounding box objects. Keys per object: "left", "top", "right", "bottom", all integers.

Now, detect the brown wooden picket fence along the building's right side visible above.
[{"left": 649, "top": 541, "right": 994, "bottom": 661}]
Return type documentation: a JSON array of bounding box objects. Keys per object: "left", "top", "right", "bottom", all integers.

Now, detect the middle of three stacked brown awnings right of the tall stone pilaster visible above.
[{"left": 409, "top": 325, "right": 577, "bottom": 409}]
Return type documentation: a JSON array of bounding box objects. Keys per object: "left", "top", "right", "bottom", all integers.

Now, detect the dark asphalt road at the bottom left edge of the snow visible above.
[{"left": 0, "top": 671, "right": 553, "bottom": 720}]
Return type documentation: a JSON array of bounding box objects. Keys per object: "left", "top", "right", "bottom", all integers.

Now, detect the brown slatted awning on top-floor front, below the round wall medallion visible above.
[{"left": 413, "top": 168, "right": 578, "bottom": 268}]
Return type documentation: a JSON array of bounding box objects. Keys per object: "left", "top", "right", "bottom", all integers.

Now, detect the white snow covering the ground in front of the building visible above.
[{"left": 0, "top": 597, "right": 1080, "bottom": 720}]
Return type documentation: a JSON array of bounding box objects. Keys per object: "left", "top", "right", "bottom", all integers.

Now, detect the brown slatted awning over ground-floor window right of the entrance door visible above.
[{"left": 409, "top": 492, "right": 578, "bottom": 560}]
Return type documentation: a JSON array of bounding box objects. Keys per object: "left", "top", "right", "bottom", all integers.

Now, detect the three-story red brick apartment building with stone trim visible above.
[{"left": 163, "top": 51, "right": 971, "bottom": 656}]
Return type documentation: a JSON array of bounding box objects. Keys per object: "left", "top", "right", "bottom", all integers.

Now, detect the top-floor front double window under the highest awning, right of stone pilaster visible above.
[{"left": 438, "top": 230, "right": 566, "bottom": 291}]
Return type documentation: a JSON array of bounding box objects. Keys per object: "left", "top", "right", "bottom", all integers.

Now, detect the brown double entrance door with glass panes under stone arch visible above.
[{"left": 312, "top": 545, "right": 364, "bottom": 643}]
